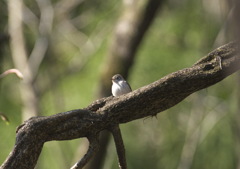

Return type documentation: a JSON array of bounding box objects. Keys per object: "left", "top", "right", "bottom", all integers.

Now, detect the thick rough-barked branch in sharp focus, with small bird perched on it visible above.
[{"left": 0, "top": 42, "right": 240, "bottom": 169}]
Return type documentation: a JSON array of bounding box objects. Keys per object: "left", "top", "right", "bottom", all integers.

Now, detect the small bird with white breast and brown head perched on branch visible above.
[{"left": 112, "top": 74, "right": 132, "bottom": 97}]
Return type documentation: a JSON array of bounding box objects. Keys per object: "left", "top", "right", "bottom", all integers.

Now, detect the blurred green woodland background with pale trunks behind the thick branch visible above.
[{"left": 0, "top": 0, "right": 240, "bottom": 169}]
